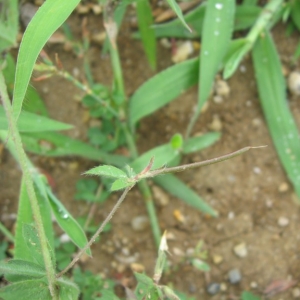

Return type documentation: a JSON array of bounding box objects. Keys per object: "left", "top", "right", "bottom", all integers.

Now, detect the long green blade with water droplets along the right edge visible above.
[{"left": 253, "top": 32, "right": 300, "bottom": 198}]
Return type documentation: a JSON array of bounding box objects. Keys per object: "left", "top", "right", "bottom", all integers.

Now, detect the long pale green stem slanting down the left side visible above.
[{"left": 0, "top": 72, "right": 58, "bottom": 299}]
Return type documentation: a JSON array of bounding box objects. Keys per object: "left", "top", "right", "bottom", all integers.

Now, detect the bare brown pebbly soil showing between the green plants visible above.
[{"left": 0, "top": 4, "right": 300, "bottom": 300}]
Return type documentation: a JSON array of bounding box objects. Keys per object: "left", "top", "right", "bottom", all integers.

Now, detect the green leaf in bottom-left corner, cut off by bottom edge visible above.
[{"left": 0, "top": 280, "right": 52, "bottom": 300}]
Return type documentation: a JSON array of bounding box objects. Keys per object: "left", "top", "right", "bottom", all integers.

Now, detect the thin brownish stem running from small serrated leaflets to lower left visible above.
[{"left": 56, "top": 185, "right": 134, "bottom": 278}]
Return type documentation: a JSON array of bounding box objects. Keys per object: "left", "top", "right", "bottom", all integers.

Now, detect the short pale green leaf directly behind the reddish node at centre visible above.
[{"left": 130, "top": 144, "right": 180, "bottom": 173}]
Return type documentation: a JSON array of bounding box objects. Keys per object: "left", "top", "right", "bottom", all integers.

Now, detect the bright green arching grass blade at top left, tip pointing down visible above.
[{"left": 13, "top": 0, "right": 80, "bottom": 119}]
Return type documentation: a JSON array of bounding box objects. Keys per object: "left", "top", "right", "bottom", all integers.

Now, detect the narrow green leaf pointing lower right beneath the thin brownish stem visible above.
[{"left": 154, "top": 174, "right": 218, "bottom": 217}]
